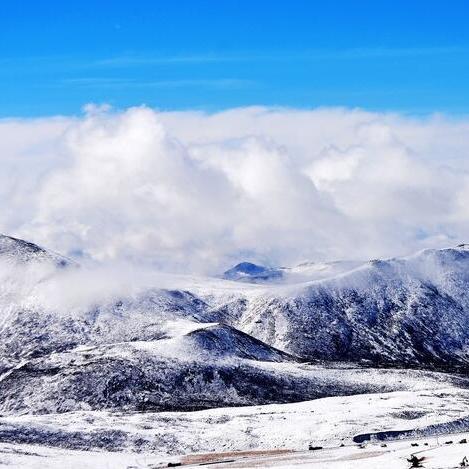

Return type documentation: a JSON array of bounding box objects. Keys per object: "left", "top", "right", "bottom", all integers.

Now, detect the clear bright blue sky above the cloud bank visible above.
[{"left": 0, "top": 0, "right": 469, "bottom": 117}]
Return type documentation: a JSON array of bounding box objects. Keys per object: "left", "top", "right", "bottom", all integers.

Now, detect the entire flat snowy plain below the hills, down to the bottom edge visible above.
[{"left": 0, "top": 384, "right": 469, "bottom": 468}]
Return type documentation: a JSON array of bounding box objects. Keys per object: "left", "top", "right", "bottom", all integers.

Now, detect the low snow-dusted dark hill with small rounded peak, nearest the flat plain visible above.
[{"left": 4, "top": 325, "right": 460, "bottom": 414}]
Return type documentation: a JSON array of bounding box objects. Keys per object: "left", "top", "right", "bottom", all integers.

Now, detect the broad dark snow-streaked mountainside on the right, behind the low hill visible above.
[{"left": 220, "top": 247, "right": 469, "bottom": 369}]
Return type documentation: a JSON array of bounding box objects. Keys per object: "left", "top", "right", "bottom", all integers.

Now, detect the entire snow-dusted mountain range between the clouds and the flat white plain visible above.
[{"left": 0, "top": 237, "right": 469, "bottom": 413}]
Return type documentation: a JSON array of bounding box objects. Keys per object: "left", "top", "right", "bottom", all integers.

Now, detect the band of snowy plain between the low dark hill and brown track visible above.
[{"left": 0, "top": 381, "right": 469, "bottom": 460}]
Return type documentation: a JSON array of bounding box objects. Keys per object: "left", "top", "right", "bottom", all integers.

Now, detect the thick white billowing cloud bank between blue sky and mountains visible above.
[{"left": 0, "top": 106, "right": 469, "bottom": 273}]
